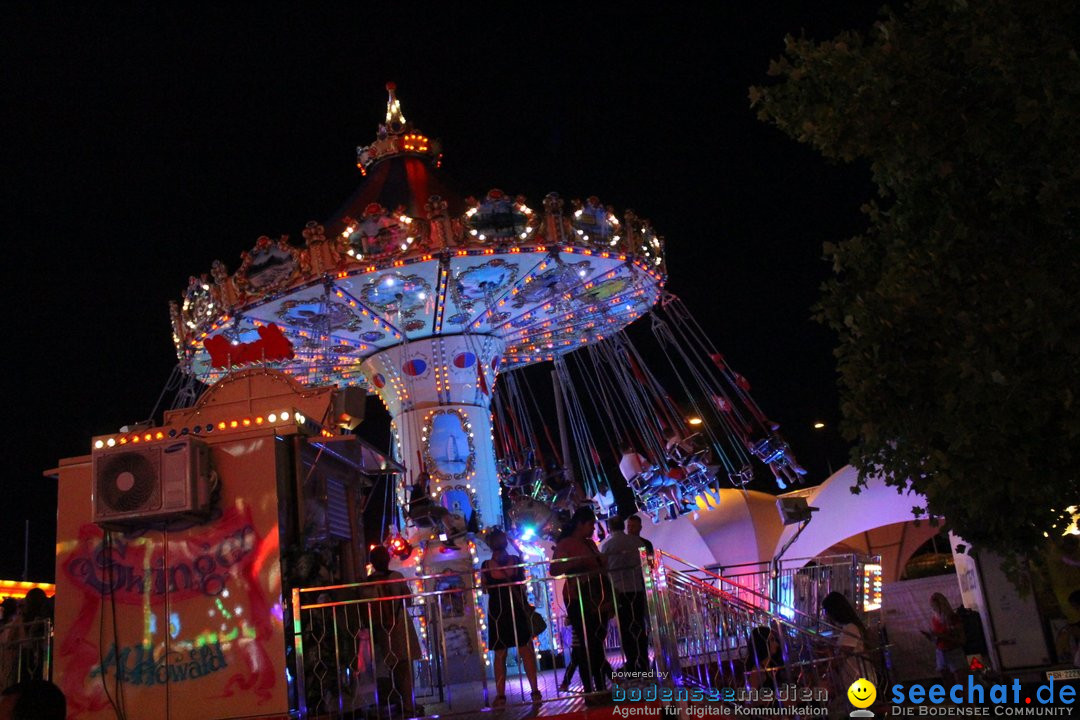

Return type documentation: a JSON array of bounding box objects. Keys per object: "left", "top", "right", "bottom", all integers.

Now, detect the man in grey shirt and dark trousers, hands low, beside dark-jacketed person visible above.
[{"left": 603, "top": 515, "right": 649, "bottom": 673}]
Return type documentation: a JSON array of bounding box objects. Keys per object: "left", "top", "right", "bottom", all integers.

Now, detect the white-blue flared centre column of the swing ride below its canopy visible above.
[{"left": 361, "top": 335, "right": 503, "bottom": 529}]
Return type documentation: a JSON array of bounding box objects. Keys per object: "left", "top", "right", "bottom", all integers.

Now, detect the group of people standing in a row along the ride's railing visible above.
[{"left": 361, "top": 507, "right": 653, "bottom": 714}]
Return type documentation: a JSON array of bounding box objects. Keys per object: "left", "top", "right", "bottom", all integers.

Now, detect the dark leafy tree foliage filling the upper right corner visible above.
[{"left": 751, "top": 0, "right": 1080, "bottom": 555}]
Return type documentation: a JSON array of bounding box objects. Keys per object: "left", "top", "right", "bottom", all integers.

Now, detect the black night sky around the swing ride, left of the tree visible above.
[{"left": 8, "top": 2, "right": 876, "bottom": 581}]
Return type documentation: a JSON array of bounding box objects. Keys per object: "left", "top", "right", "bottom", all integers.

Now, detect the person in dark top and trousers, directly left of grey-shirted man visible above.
[{"left": 551, "top": 507, "right": 615, "bottom": 703}]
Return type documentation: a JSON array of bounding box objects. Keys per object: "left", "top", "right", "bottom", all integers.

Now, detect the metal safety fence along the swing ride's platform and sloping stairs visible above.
[{"left": 292, "top": 551, "right": 875, "bottom": 718}]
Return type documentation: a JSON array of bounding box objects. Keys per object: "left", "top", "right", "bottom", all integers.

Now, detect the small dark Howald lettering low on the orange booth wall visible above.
[{"left": 90, "top": 642, "right": 228, "bottom": 685}]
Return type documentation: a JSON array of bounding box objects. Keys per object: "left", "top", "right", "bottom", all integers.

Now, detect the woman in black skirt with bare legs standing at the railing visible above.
[{"left": 480, "top": 529, "right": 542, "bottom": 707}]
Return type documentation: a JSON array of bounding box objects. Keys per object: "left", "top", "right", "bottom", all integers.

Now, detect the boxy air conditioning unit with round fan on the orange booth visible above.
[{"left": 92, "top": 437, "right": 210, "bottom": 527}]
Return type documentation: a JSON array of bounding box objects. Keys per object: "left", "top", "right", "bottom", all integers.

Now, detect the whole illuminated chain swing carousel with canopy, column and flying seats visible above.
[{"left": 171, "top": 84, "right": 805, "bottom": 562}]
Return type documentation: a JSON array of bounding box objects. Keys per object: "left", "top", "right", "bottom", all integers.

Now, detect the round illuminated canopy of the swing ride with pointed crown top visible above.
[{"left": 171, "top": 84, "right": 666, "bottom": 391}]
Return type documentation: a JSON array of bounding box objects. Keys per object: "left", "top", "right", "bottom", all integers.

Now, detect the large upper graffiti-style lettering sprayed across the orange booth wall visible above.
[{"left": 67, "top": 526, "right": 256, "bottom": 597}]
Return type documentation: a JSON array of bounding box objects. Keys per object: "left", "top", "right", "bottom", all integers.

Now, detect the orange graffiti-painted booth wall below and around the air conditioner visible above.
[{"left": 54, "top": 430, "right": 288, "bottom": 720}]
